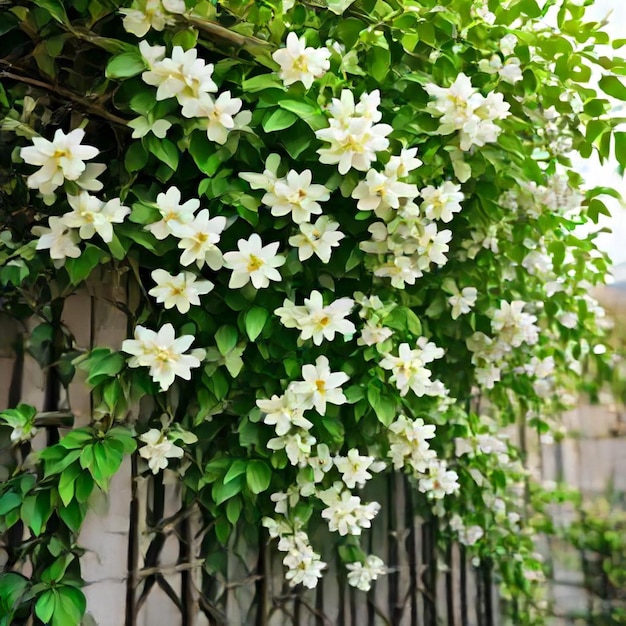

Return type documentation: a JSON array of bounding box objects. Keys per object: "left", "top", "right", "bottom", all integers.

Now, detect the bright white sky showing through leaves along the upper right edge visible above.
[{"left": 581, "top": 0, "right": 626, "bottom": 265}]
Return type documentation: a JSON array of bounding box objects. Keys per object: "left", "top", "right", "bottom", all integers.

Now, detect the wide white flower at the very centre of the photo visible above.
[{"left": 274, "top": 291, "right": 356, "bottom": 346}]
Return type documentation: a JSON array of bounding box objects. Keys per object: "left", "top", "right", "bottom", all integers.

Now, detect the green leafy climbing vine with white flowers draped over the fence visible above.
[{"left": 0, "top": 0, "right": 626, "bottom": 626}]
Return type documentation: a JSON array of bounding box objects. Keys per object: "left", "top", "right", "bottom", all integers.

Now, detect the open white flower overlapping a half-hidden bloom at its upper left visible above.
[{"left": 262, "top": 170, "right": 330, "bottom": 224}]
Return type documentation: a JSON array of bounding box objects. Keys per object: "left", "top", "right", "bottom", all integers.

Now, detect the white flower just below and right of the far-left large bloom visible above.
[{"left": 63, "top": 191, "right": 130, "bottom": 243}]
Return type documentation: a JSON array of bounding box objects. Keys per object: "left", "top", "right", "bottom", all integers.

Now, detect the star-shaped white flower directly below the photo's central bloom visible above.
[{"left": 289, "top": 356, "right": 349, "bottom": 415}]
